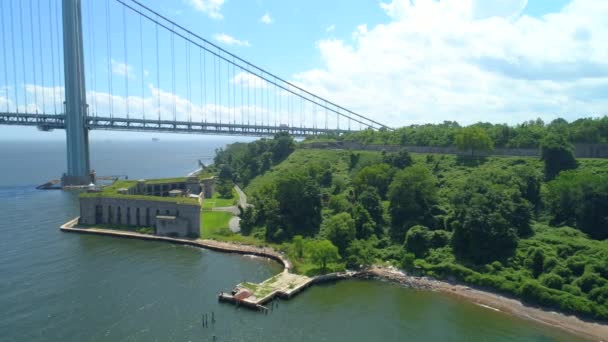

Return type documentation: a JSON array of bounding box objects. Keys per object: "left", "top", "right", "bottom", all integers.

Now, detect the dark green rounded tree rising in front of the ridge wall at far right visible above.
[{"left": 540, "top": 134, "right": 577, "bottom": 180}]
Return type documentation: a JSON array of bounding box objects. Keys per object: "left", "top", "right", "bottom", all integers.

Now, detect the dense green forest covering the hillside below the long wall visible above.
[{"left": 213, "top": 127, "right": 608, "bottom": 320}]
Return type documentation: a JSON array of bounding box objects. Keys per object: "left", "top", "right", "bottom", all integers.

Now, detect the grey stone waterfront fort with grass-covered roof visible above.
[{"left": 79, "top": 177, "right": 215, "bottom": 237}]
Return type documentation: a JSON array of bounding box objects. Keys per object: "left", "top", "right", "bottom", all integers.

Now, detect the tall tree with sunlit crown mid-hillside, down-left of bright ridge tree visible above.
[{"left": 388, "top": 165, "right": 438, "bottom": 242}]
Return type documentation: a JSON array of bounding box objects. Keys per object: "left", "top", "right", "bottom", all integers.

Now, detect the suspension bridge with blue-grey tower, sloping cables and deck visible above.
[{"left": 0, "top": 0, "right": 388, "bottom": 185}]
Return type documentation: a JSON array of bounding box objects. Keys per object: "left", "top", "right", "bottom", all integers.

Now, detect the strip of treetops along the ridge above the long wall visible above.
[{"left": 307, "top": 116, "right": 608, "bottom": 148}]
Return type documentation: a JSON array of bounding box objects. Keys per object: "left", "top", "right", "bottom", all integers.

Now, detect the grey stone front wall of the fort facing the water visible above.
[{"left": 79, "top": 197, "right": 201, "bottom": 237}]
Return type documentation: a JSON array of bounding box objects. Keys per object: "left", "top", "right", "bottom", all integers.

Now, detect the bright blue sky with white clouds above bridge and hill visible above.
[{"left": 0, "top": 0, "right": 608, "bottom": 140}]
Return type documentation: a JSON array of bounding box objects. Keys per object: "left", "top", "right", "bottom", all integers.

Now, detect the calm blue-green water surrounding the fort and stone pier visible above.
[{"left": 0, "top": 139, "right": 576, "bottom": 341}]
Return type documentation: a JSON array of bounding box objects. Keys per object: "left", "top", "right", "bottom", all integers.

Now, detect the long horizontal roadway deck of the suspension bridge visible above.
[{"left": 0, "top": 112, "right": 351, "bottom": 137}]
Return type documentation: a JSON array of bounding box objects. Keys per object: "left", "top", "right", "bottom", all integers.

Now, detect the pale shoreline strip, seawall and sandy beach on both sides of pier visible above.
[{"left": 60, "top": 218, "right": 608, "bottom": 341}]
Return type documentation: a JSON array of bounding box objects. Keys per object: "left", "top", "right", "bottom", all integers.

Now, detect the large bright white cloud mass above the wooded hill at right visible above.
[{"left": 294, "top": 0, "right": 608, "bottom": 126}]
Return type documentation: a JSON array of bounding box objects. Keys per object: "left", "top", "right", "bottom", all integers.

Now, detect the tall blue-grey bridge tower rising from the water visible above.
[{"left": 61, "top": 0, "right": 94, "bottom": 185}]
